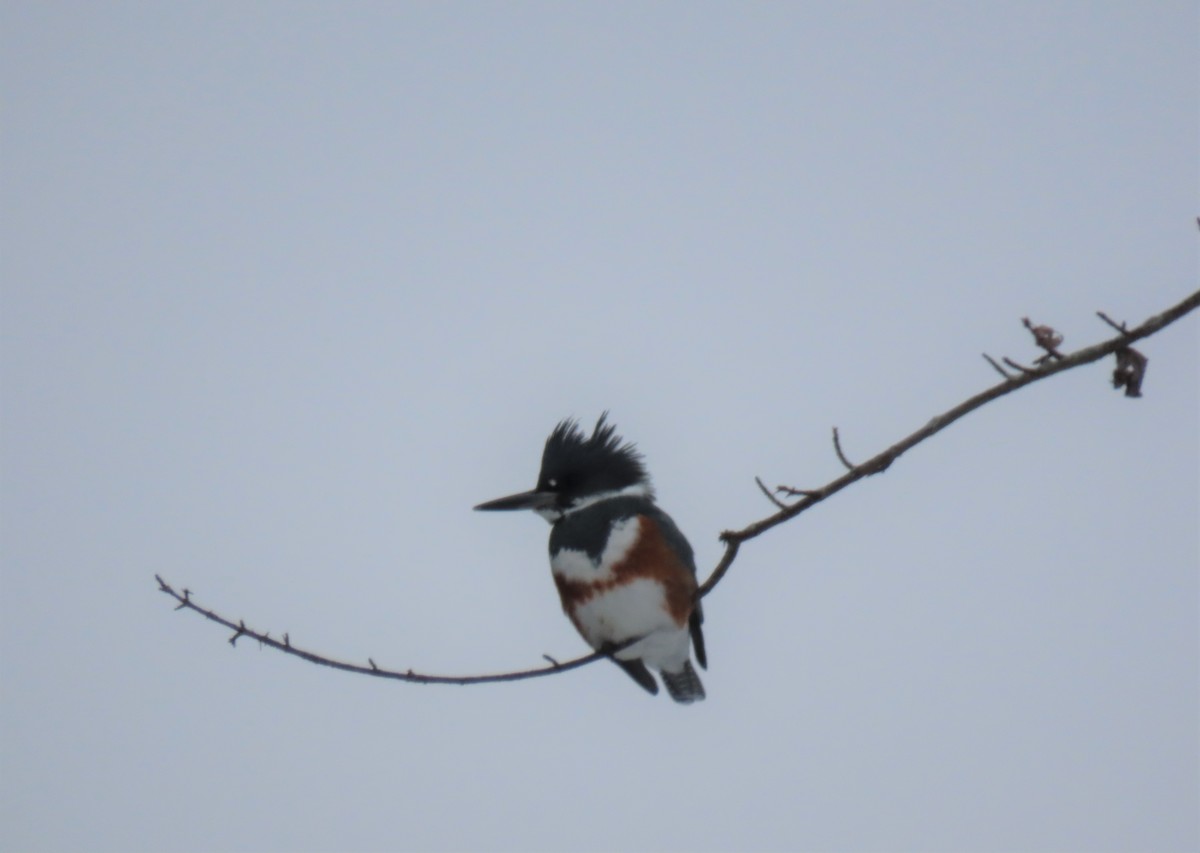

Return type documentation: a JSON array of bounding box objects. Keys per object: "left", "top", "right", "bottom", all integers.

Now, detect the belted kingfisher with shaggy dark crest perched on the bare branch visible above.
[{"left": 475, "top": 413, "right": 708, "bottom": 703}]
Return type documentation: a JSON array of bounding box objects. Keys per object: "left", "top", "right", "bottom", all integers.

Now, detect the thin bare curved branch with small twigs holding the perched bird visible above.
[{"left": 155, "top": 290, "right": 1200, "bottom": 684}]
